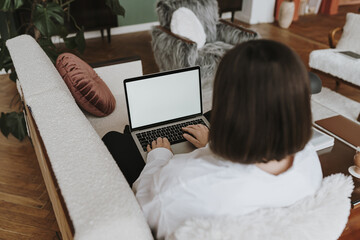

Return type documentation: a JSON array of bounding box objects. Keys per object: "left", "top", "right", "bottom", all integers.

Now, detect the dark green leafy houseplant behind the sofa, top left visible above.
[{"left": 0, "top": 0, "right": 125, "bottom": 140}]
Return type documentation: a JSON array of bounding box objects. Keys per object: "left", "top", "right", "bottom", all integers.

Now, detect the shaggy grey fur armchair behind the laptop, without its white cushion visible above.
[{"left": 152, "top": 0, "right": 259, "bottom": 89}]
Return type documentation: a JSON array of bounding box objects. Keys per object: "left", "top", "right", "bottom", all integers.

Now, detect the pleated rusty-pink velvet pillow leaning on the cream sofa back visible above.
[{"left": 56, "top": 53, "right": 116, "bottom": 117}]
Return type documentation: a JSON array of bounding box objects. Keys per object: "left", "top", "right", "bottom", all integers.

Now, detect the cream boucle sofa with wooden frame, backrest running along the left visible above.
[{"left": 7, "top": 35, "right": 153, "bottom": 240}]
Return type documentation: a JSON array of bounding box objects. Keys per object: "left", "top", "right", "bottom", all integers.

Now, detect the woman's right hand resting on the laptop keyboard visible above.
[{"left": 182, "top": 124, "right": 209, "bottom": 148}]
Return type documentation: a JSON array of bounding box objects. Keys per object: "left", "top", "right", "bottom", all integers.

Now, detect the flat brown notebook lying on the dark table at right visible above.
[{"left": 314, "top": 115, "right": 360, "bottom": 149}]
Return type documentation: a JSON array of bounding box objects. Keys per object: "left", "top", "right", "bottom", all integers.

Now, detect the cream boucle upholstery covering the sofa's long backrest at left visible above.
[{"left": 6, "top": 35, "right": 153, "bottom": 240}]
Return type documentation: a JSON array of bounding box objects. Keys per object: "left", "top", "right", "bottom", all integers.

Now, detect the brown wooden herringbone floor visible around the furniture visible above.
[{"left": 0, "top": 5, "right": 360, "bottom": 240}]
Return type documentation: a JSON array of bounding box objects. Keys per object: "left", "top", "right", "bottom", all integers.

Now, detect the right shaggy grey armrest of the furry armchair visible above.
[{"left": 216, "top": 19, "right": 260, "bottom": 45}]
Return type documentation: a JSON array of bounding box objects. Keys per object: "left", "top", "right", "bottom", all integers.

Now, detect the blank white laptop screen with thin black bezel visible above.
[{"left": 124, "top": 67, "right": 202, "bottom": 129}]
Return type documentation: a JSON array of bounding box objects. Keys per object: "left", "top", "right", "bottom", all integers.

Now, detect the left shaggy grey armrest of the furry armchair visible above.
[{"left": 151, "top": 26, "right": 198, "bottom": 71}]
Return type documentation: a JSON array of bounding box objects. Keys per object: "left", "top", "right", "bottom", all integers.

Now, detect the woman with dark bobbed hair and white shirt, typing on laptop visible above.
[{"left": 102, "top": 40, "right": 322, "bottom": 238}]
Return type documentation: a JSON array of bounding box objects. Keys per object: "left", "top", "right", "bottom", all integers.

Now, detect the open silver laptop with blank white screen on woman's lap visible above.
[{"left": 124, "top": 66, "right": 210, "bottom": 161}]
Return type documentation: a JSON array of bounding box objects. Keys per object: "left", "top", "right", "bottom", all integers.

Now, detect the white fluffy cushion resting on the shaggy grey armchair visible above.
[{"left": 170, "top": 7, "right": 206, "bottom": 49}]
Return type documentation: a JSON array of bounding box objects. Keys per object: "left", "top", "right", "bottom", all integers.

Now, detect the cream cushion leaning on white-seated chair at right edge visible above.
[{"left": 336, "top": 13, "right": 360, "bottom": 53}]
